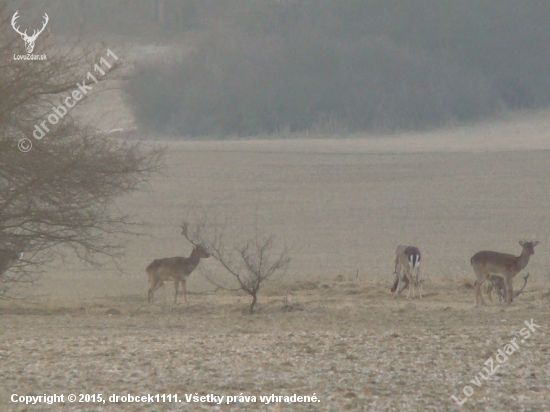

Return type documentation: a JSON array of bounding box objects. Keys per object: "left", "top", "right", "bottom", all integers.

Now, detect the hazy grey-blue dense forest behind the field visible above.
[{"left": 23, "top": 0, "right": 550, "bottom": 136}]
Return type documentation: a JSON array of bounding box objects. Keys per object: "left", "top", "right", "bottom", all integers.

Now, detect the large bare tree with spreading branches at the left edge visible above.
[{"left": 0, "top": 0, "right": 162, "bottom": 298}]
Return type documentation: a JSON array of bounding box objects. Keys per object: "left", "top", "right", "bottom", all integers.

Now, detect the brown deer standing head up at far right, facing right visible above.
[{"left": 470, "top": 240, "right": 539, "bottom": 305}]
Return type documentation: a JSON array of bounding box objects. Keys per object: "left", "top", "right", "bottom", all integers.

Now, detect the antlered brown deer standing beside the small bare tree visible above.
[{"left": 145, "top": 224, "right": 210, "bottom": 305}]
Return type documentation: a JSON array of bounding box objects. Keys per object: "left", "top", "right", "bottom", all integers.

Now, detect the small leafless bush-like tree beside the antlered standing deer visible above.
[{"left": 183, "top": 212, "right": 290, "bottom": 314}]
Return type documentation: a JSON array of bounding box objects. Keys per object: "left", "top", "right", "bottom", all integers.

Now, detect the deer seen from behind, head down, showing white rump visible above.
[{"left": 391, "top": 245, "right": 422, "bottom": 298}]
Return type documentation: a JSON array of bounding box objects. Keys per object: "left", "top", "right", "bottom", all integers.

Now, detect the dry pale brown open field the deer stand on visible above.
[{"left": 0, "top": 114, "right": 550, "bottom": 411}]
